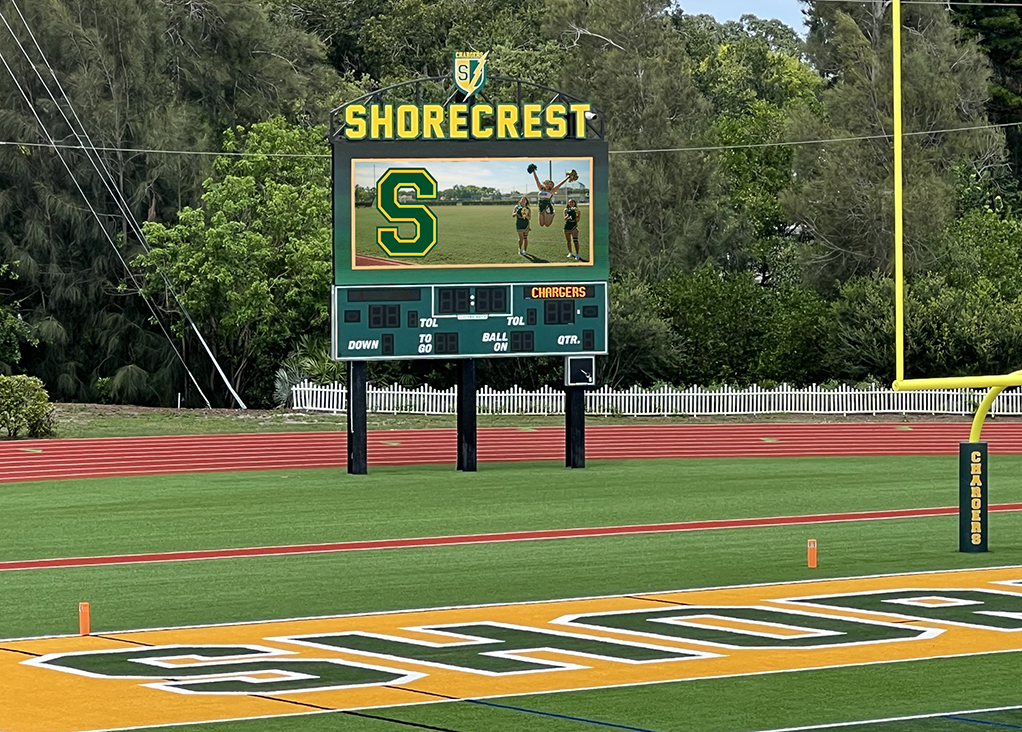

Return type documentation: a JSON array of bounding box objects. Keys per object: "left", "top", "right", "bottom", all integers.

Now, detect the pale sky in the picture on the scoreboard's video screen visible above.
[{"left": 355, "top": 157, "right": 590, "bottom": 193}]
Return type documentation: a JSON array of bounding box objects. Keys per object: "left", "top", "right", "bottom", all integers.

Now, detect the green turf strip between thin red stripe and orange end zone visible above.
[{"left": 7, "top": 513, "right": 1022, "bottom": 637}]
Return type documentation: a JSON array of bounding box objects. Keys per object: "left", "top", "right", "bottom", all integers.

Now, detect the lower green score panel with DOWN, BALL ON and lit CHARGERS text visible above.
[{"left": 333, "top": 282, "right": 607, "bottom": 361}]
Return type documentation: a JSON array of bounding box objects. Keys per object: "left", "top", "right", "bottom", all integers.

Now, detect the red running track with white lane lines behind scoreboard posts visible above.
[{"left": 6, "top": 423, "right": 1022, "bottom": 483}]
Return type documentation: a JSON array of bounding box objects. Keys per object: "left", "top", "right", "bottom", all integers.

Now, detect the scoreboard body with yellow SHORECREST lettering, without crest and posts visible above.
[{"left": 331, "top": 85, "right": 609, "bottom": 361}]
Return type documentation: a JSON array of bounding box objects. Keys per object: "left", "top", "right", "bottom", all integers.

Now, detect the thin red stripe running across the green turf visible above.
[{"left": 6, "top": 503, "right": 1022, "bottom": 571}]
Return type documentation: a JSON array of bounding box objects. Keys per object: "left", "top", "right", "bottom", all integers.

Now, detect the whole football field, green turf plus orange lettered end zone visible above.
[{"left": 6, "top": 425, "right": 1022, "bottom": 732}]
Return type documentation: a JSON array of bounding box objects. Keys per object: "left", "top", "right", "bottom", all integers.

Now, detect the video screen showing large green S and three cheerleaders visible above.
[{"left": 351, "top": 157, "right": 594, "bottom": 270}]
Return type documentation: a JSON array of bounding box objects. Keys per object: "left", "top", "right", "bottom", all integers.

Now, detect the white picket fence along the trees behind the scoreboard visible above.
[{"left": 291, "top": 381, "right": 1022, "bottom": 417}]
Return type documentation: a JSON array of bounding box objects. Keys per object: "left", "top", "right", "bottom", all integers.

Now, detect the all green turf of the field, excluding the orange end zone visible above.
[{"left": 6, "top": 456, "right": 1022, "bottom": 732}]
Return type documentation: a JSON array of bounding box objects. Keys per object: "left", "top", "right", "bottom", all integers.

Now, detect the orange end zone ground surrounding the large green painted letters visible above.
[{"left": 6, "top": 567, "right": 1022, "bottom": 732}]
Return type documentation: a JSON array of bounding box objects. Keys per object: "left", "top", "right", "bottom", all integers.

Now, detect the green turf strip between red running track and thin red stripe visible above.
[{"left": 0, "top": 456, "right": 1005, "bottom": 559}]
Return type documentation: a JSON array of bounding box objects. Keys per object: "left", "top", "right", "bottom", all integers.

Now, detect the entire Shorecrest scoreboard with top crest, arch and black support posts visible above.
[{"left": 333, "top": 68, "right": 610, "bottom": 474}]
